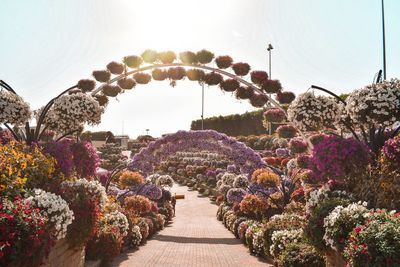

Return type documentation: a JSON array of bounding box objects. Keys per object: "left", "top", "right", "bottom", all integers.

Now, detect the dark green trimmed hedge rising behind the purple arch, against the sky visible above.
[{"left": 190, "top": 109, "right": 267, "bottom": 136}]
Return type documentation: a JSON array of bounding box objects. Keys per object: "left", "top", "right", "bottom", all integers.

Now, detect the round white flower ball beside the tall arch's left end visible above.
[{"left": 37, "top": 93, "right": 104, "bottom": 133}]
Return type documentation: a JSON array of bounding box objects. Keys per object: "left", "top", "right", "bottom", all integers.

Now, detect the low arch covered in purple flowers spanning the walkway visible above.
[{"left": 128, "top": 130, "right": 267, "bottom": 174}]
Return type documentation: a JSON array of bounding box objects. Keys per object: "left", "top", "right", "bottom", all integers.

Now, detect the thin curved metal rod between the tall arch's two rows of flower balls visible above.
[{"left": 92, "top": 63, "right": 287, "bottom": 114}]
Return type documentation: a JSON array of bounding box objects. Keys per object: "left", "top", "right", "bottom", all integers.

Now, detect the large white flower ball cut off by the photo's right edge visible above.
[{"left": 346, "top": 79, "right": 400, "bottom": 127}]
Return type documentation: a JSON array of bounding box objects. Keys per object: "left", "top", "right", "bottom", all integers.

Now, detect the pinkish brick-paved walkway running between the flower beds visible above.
[{"left": 111, "top": 186, "right": 272, "bottom": 267}]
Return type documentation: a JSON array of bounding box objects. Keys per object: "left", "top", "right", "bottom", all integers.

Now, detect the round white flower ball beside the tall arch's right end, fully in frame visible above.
[{"left": 287, "top": 92, "right": 340, "bottom": 131}]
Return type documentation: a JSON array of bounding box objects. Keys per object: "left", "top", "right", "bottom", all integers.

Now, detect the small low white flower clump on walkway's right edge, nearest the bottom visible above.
[{"left": 269, "top": 229, "right": 303, "bottom": 258}]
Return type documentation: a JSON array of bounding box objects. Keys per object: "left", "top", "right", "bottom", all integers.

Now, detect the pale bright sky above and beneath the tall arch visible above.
[{"left": 0, "top": 0, "right": 400, "bottom": 137}]
